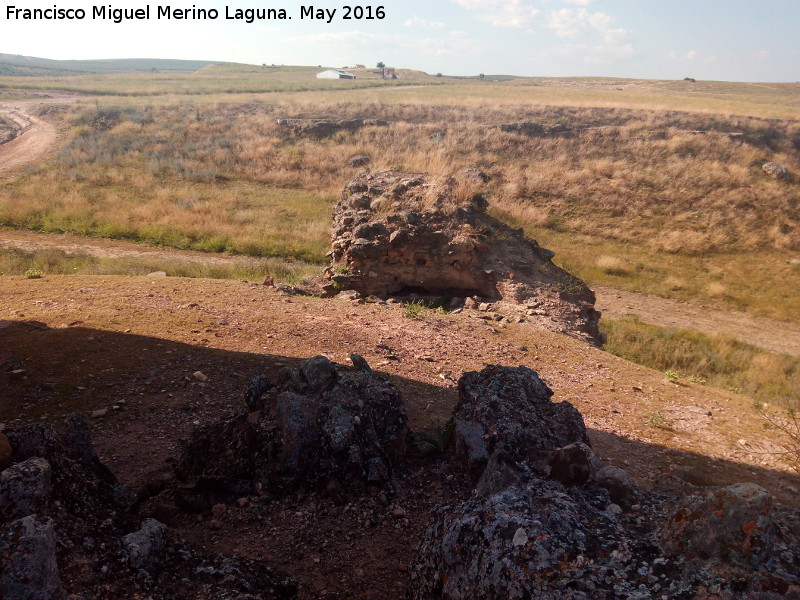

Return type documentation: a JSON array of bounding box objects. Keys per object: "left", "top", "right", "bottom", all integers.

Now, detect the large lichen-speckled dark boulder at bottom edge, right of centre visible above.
[{"left": 409, "top": 479, "right": 620, "bottom": 600}]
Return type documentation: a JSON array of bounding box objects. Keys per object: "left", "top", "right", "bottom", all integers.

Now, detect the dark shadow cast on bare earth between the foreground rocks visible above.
[{"left": 0, "top": 321, "right": 800, "bottom": 600}]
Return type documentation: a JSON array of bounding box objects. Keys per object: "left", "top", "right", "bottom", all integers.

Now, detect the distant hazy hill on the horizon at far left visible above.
[{"left": 0, "top": 53, "right": 236, "bottom": 77}]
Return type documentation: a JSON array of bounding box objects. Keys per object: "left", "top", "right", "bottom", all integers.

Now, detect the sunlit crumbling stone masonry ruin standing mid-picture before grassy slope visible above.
[{"left": 325, "top": 169, "right": 600, "bottom": 339}]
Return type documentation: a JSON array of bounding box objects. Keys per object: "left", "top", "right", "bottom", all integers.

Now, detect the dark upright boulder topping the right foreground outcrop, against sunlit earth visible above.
[{"left": 453, "top": 366, "right": 589, "bottom": 480}]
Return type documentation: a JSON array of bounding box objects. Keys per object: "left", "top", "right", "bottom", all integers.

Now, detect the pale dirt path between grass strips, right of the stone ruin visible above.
[{"left": 595, "top": 288, "right": 800, "bottom": 355}]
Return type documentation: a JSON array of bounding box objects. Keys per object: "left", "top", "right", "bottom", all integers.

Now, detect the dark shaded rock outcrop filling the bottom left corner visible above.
[{"left": 0, "top": 415, "right": 296, "bottom": 600}]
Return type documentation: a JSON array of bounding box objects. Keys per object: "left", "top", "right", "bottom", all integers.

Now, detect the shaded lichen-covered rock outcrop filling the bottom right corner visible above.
[{"left": 409, "top": 367, "right": 800, "bottom": 600}]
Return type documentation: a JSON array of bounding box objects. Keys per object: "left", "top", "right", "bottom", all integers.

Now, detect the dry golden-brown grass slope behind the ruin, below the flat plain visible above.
[{"left": 0, "top": 98, "right": 800, "bottom": 319}]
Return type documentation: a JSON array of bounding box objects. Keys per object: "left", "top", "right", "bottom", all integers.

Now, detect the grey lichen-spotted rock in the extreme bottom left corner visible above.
[{"left": 0, "top": 515, "right": 66, "bottom": 600}]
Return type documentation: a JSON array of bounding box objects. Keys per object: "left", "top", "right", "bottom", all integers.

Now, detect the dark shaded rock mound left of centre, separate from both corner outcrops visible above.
[{"left": 175, "top": 355, "right": 410, "bottom": 509}]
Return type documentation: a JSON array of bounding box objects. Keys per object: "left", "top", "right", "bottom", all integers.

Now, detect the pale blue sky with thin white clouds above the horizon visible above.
[{"left": 0, "top": 0, "right": 800, "bottom": 82}]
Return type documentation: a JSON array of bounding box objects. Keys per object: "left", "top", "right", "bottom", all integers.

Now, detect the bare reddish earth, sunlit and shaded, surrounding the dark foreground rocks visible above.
[{"left": 0, "top": 275, "right": 800, "bottom": 600}]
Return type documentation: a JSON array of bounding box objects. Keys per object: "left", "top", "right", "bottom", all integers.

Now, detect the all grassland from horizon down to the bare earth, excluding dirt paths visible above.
[{"left": 0, "top": 65, "right": 800, "bottom": 474}]
